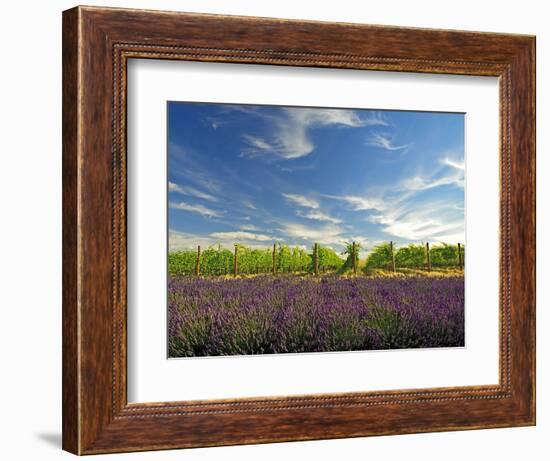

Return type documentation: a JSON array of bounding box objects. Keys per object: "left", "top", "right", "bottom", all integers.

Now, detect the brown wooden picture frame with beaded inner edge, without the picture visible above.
[{"left": 63, "top": 7, "right": 535, "bottom": 454}]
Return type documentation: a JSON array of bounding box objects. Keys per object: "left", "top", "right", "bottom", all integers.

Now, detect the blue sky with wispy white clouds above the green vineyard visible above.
[{"left": 168, "top": 102, "right": 464, "bottom": 252}]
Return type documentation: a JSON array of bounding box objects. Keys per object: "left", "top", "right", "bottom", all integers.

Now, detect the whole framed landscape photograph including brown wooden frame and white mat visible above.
[{"left": 63, "top": 7, "right": 535, "bottom": 454}]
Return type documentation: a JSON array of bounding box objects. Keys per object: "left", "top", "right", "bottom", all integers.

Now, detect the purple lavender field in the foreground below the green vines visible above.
[{"left": 168, "top": 276, "right": 464, "bottom": 357}]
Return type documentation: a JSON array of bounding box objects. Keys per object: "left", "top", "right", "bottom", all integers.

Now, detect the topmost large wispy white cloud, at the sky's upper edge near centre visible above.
[{"left": 241, "top": 107, "right": 387, "bottom": 160}]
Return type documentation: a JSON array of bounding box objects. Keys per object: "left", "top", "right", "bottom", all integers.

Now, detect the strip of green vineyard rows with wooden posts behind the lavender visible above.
[{"left": 168, "top": 242, "right": 464, "bottom": 276}]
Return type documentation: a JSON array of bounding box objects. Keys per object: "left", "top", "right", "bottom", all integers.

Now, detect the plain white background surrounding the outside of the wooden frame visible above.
[{"left": 0, "top": 0, "right": 550, "bottom": 461}]
